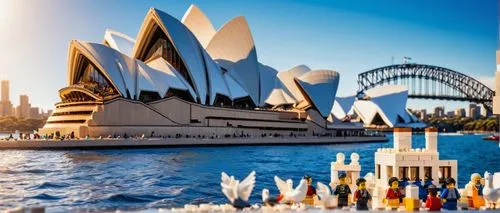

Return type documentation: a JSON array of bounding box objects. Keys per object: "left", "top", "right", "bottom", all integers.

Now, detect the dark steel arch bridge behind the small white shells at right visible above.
[{"left": 358, "top": 63, "right": 495, "bottom": 111}]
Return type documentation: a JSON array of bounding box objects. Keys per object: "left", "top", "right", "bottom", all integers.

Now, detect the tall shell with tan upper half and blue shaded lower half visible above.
[{"left": 207, "top": 16, "right": 260, "bottom": 105}]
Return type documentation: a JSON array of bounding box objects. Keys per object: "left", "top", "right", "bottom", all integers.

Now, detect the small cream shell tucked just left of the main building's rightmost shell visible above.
[{"left": 278, "top": 65, "right": 311, "bottom": 101}]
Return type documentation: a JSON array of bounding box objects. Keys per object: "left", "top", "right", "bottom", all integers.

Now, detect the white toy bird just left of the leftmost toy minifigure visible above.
[{"left": 274, "top": 176, "right": 307, "bottom": 203}]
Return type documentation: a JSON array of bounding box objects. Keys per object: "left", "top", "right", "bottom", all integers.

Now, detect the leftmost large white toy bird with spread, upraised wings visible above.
[{"left": 220, "top": 171, "right": 255, "bottom": 209}]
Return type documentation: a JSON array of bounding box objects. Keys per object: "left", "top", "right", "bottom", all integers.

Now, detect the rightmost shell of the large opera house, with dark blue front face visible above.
[{"left": 295, "top": 70, "right": 339, "bottom": 118}]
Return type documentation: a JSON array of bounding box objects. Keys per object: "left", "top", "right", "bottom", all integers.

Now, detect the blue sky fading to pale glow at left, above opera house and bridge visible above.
[{"left": 0, "top": 0, "right": 498, "bottom": 114}]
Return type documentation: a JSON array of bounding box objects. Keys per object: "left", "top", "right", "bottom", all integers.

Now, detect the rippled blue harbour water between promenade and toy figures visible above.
[{"left": 0, "top": 135, "right": 500, "bottom": 210}]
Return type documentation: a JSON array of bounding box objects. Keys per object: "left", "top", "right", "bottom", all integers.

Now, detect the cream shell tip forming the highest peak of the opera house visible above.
[{"left": 182, "top": 4, "right": 216, "bottom": 47}]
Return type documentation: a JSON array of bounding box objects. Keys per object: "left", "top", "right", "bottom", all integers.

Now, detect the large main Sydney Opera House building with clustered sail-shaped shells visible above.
[{"left": 39, "top": 5, "right": 360, "bottom": 137}]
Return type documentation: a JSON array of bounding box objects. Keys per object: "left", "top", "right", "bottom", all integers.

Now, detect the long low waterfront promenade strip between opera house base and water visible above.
[{"left": 0, "top": 136, "right": 388, "bottom": 149}]
